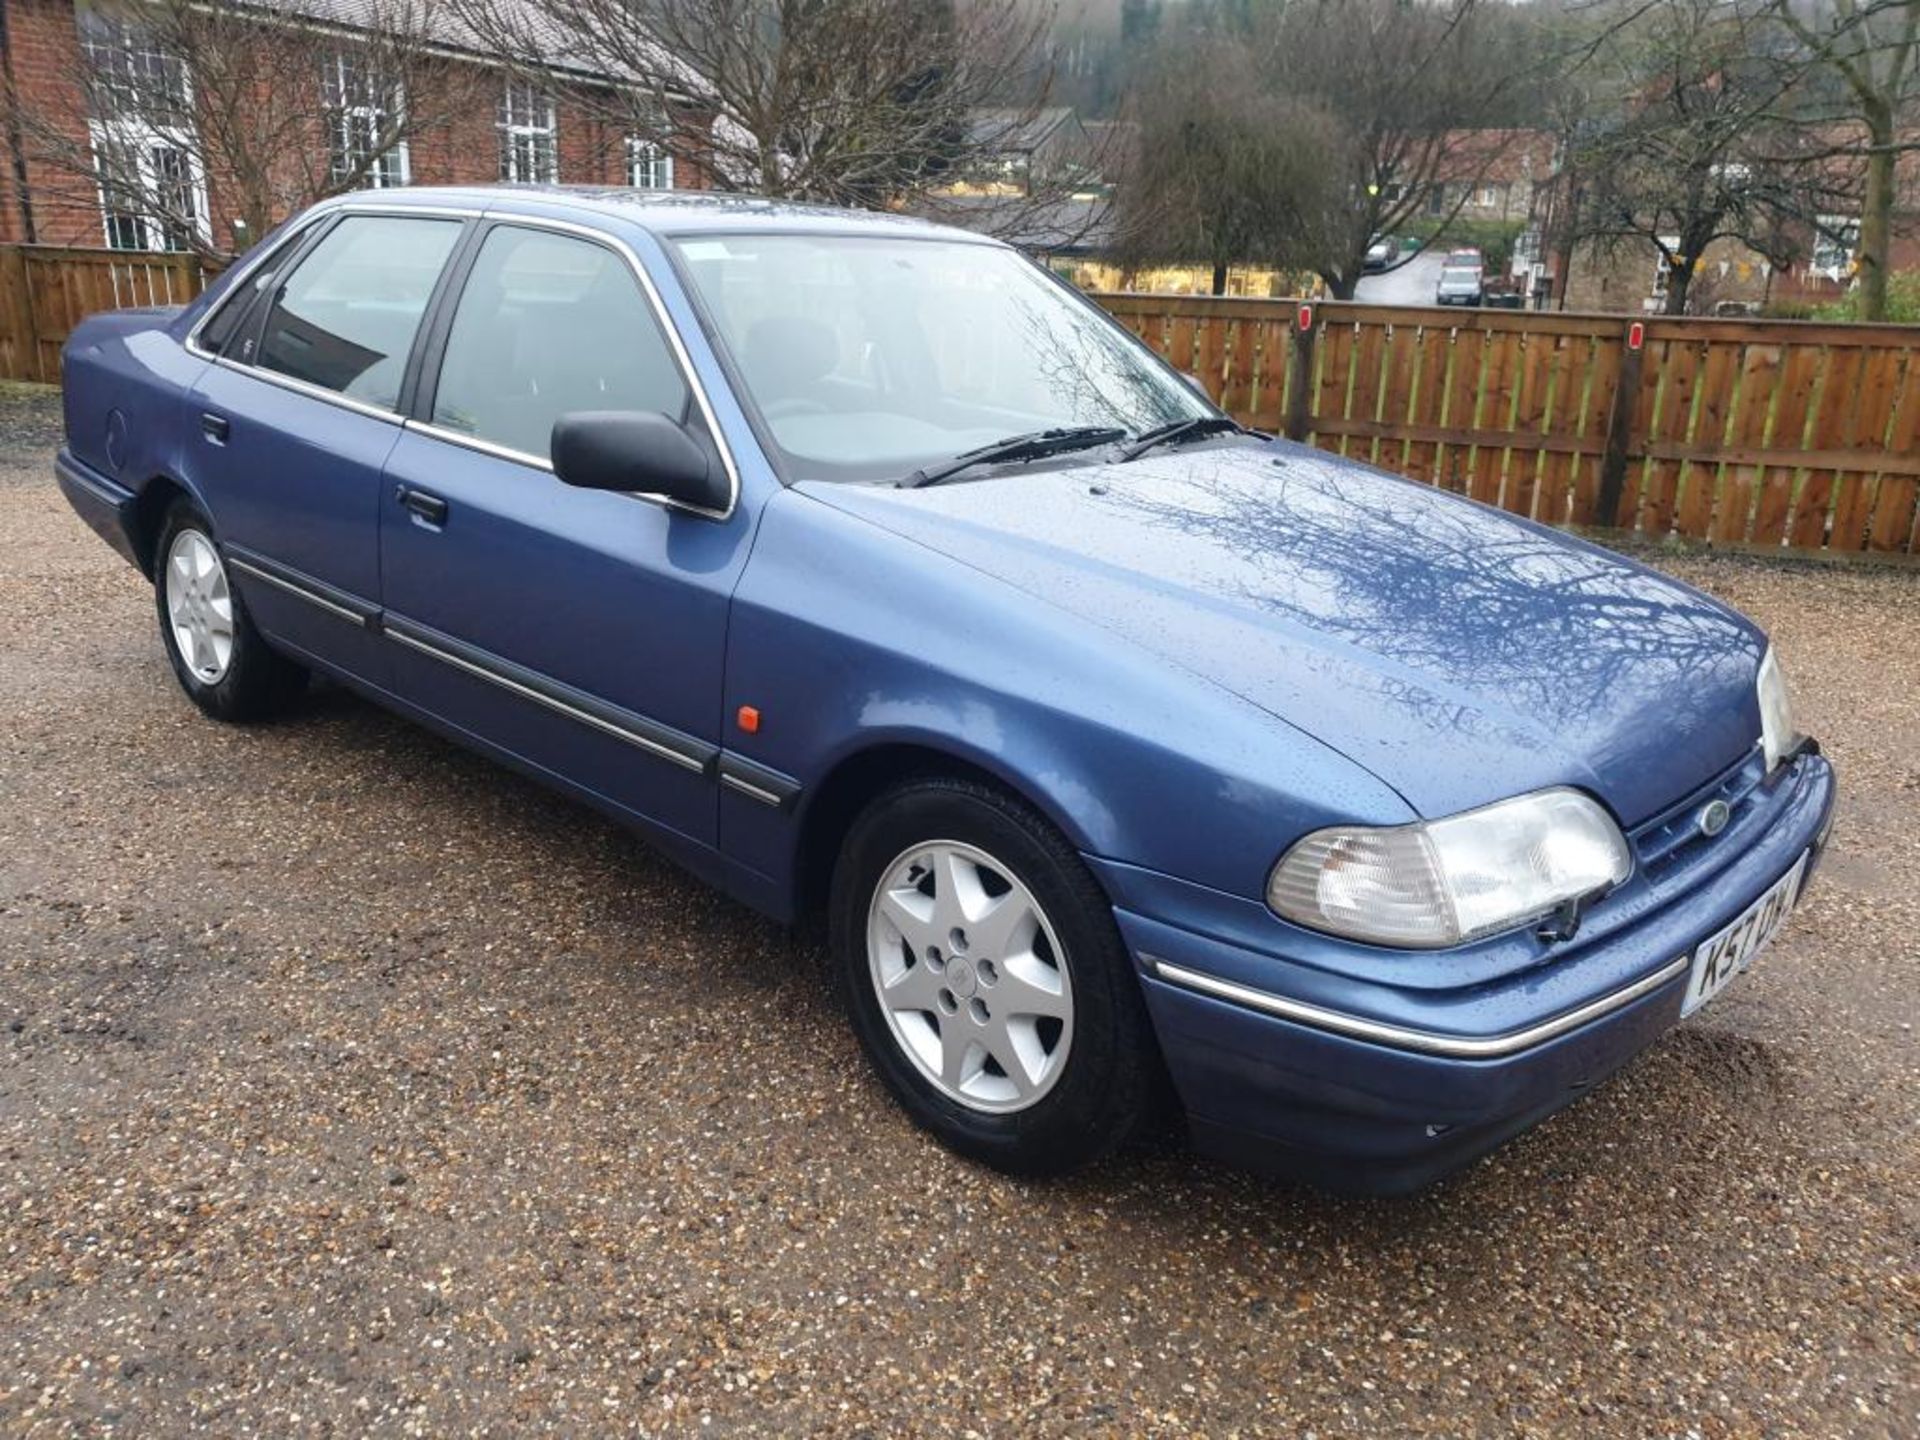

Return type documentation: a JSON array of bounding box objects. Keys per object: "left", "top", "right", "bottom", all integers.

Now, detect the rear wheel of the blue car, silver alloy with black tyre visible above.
[{"left": 154, "top": 499, "right": 307, "bottom": 722}]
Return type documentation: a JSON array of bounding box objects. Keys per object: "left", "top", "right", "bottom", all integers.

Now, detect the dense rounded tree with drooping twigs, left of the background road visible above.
[{"left": 1117, "top": 33, "right": 1350, "bottom": 296}]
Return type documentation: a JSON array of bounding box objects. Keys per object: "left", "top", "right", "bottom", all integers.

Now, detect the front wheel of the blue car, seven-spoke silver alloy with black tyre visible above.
[{"left": 829, "top": 778, "right": 1160, "bottom": 1175}]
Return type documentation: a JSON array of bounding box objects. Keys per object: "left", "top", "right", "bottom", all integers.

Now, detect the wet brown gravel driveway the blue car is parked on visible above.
[{"left": 0, "top": 389, "right": 1920, "bottom": 1436}]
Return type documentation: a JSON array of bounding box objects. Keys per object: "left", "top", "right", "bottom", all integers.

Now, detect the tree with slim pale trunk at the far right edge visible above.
[{"left": 1768, "top": 0, "right": 1920, "bottom": 321}]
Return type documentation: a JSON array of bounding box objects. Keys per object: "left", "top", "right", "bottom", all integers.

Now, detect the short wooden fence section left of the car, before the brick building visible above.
[{"left": 0, "top": 246, "right": 205, "bottom": 384}]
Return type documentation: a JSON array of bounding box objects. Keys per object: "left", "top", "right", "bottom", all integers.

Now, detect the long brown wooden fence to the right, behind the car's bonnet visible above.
[{"left": 1098, "top": 296, "right": 1920, "bottom": 555}]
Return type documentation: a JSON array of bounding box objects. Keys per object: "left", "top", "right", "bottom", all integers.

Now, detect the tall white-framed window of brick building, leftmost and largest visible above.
[{"left": 75, "top": 6, "right": 207, "bottom": 250}]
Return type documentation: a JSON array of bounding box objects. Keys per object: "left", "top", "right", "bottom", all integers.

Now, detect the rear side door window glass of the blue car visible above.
[{"left": 255, "top": 215, "right": 461, "bottom": 409}]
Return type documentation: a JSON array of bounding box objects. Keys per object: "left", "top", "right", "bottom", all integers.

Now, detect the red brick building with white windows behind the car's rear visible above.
[{"left": 0, "top": 0, "right": 708, "bottom": 250}]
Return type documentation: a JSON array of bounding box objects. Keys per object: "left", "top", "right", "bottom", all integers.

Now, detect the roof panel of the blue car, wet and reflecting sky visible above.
[{"left": 314, "top": 184, "right": 1000, "bottom": 244}]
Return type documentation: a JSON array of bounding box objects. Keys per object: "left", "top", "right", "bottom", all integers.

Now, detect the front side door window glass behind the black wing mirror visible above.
[{"left": 432, "top": 225, "right": 687, "bottom": 459}]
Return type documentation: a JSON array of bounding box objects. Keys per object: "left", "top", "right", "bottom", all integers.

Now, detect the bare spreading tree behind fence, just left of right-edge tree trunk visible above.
[{"left": 1569, "top": 0, "right": 1822, "bottom": 315}]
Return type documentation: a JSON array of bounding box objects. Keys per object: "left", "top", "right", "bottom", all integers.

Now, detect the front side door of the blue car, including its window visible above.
[{"left": 380, "top": 221, "right": 749, "bottom": 845}]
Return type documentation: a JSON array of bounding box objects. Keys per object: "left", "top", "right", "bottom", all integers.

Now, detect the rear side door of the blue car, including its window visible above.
[{"left": 186, "top": 213, "right": 465, "bottom": 685}]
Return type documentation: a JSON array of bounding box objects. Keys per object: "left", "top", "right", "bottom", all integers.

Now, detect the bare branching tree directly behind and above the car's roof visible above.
[{"left": 455, "top": 0, "right": 1046, "bottom": 205}]
